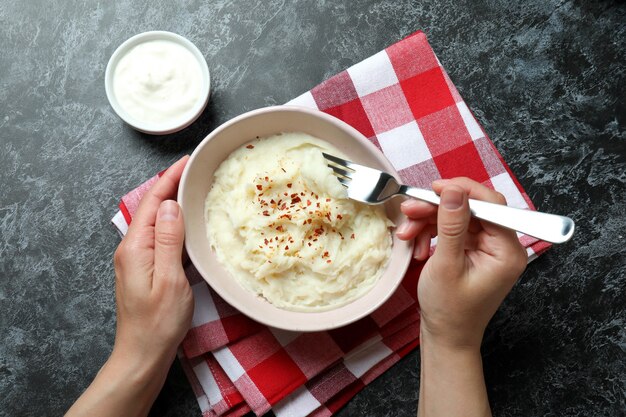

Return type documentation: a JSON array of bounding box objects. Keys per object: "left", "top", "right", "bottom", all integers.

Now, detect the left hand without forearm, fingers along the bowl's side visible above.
[{"left": 113, "top": 157, "right": 193, "bottom": 366}]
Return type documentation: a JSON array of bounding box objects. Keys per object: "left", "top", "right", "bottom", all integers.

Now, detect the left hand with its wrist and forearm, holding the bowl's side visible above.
[{"left": 66, "top": 156, "right": 193, "bottom": 417}]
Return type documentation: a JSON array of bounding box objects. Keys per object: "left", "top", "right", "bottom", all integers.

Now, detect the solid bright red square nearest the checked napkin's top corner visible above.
[{"left": 400, "top": 67, "right": 455, "bottom": 120}]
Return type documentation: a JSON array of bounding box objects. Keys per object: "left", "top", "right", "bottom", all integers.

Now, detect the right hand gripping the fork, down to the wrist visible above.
[{"left": 397, "top": 178, "right": 527, "bottom": 349}]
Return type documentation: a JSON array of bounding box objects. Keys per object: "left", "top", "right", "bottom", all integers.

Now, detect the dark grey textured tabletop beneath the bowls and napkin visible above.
[{"left": 0, "top": 0, "right": 626, "bottom": 416}]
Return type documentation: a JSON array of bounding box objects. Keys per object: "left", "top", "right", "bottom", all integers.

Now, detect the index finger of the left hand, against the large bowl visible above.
[{"left": 128, "top": 155, "right": 189, "bottom": 238}]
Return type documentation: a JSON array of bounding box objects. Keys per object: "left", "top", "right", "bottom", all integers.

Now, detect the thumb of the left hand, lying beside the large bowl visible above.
[{"left": 154, "top": 200, "right": 185, "bottom": 280}]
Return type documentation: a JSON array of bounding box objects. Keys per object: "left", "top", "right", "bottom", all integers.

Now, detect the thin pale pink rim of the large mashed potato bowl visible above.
[{"left": 177, "top": 105, "right": 414, "bottom": 332}]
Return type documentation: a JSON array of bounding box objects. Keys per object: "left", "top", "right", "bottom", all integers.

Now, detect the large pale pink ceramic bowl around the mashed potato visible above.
[{"left": 178, "top": 106, "right": 413, "bottom": 331}]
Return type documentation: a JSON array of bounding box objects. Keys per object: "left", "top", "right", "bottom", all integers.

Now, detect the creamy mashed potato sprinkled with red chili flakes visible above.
[{"left": 205, "top": 133, "right": 393, "bottom": 311}]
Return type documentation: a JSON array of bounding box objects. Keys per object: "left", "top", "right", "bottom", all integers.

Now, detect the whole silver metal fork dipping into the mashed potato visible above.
[{"left": 323, "top": 153, "right": 574, "bottom": 243}]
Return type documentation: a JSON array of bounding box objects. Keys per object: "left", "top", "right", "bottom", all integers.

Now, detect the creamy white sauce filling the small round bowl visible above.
[{"left": 113, "top": 40, "right": 203, "bottom": 125}]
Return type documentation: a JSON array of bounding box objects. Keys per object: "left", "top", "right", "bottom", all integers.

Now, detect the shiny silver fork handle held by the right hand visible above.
[{"left": 400, "top": 186, "right": 575, "bottom": 243}]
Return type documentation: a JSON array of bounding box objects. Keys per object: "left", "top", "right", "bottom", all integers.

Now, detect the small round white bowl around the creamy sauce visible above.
[{"left": 104, "top": 31, "right": 211, "bottom": 135}]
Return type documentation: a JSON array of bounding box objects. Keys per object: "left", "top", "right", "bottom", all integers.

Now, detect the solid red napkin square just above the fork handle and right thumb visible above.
[{"left": 434, "top": 142, "right": 489, "bottom": 183}]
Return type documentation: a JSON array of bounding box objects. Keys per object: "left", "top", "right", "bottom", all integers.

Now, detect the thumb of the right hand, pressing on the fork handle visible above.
[{"left": 433, "top": 185, "right": 470, "bottom": 268}]
